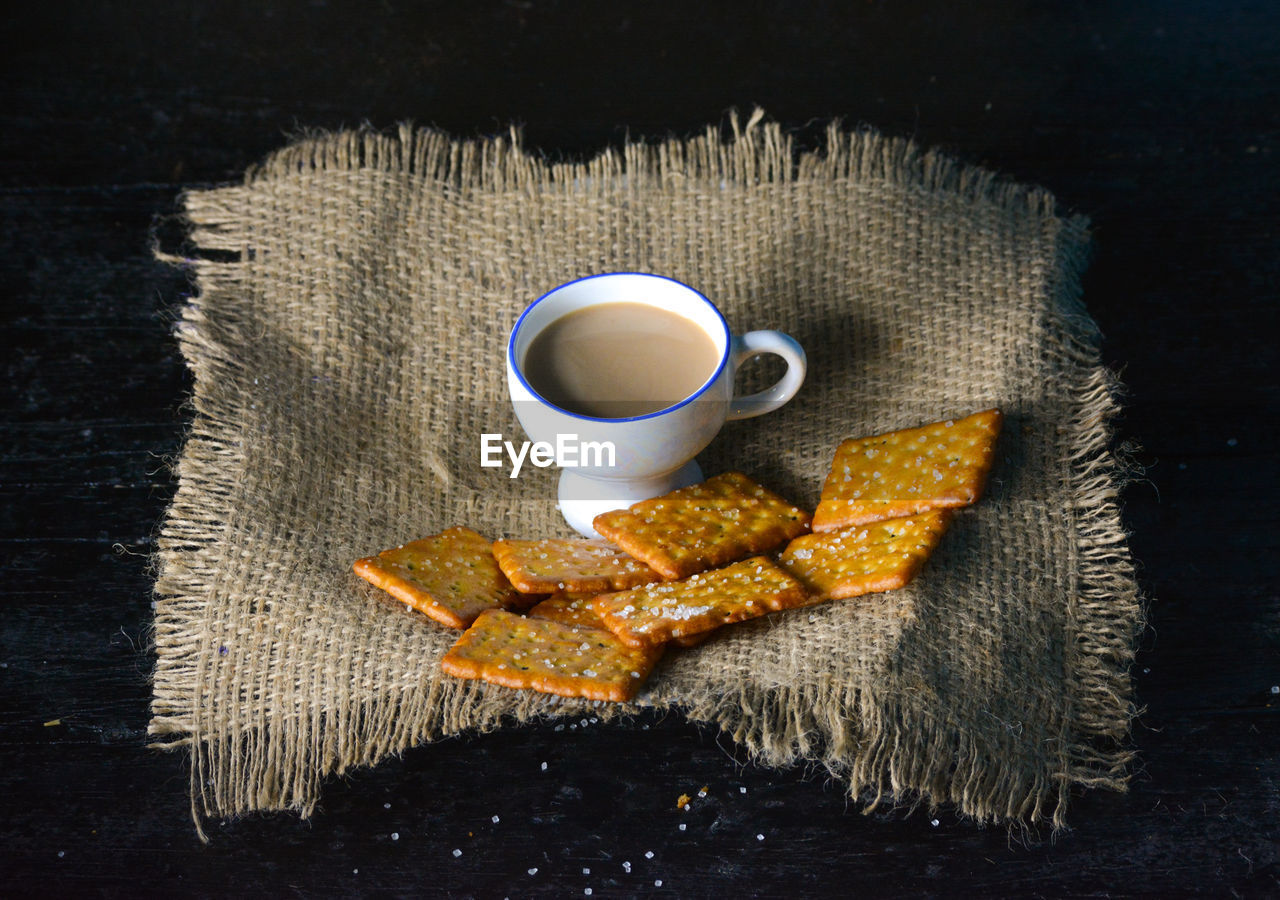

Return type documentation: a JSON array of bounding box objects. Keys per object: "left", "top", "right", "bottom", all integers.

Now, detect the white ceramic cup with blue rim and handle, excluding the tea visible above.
[{"left": 507, "top": 267, "right": 805, "bottom": 536}]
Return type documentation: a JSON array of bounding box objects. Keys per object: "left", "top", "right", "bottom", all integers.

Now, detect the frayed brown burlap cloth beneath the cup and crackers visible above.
[{"left": 151, "top": 113, "right": 1140, "bottom": 826}]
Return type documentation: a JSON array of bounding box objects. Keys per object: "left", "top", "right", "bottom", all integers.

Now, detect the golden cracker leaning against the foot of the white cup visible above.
[{"left": 591, "top": 472, "right": 809, "bottom": 579}]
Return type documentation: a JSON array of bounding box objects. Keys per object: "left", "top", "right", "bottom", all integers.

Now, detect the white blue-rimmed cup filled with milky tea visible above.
[{"left": 507, "top": 273, "right": 805, "bottom": 536}]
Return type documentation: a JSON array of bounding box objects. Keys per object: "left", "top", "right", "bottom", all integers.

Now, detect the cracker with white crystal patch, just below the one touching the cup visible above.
[{"left": 591, "top": 556, "right": 808, "bottom": 647}]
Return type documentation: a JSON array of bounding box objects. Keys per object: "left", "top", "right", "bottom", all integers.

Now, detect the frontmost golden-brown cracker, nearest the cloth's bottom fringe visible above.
[{"left": 440, "top": 609, "right": 662, "bottom": 702}]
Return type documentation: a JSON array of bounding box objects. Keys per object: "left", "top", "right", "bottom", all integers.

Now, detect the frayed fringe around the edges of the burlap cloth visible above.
[{"left": 150, "top": 110, "right": 1142, "bottom": 837}]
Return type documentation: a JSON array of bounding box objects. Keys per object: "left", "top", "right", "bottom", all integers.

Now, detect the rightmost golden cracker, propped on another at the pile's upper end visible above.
[{"left": 813, "top": 410, "right": 1001, "bottom": 531}]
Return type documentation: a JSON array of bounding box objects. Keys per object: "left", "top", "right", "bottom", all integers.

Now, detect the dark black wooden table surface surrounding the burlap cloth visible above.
[{"left": 0, "top": 0, "right": 1280, "bottom": 897}]
